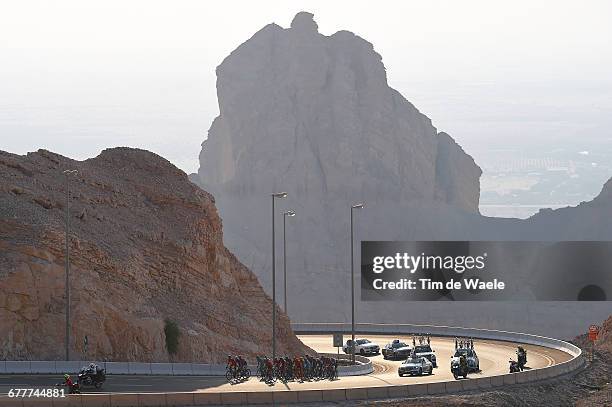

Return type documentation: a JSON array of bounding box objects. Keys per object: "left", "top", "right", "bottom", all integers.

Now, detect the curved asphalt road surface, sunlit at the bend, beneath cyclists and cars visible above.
[{"left": 0, "top": 334, "right": 571, "bottom": 395}]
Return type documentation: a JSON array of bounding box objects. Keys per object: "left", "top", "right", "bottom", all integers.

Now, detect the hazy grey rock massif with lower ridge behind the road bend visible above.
[{"left": 193, "top": 12, "right": 612, "bottom": 337}]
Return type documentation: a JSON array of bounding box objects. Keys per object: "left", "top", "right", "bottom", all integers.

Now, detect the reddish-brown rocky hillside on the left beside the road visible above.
[{"left": 0, "top": 148, "right": 307, "bottom": 362}]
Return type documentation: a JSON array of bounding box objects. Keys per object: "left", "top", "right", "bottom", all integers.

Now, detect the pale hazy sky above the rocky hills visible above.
[{"left": 0, "top": 0, "right": 612, "bottom": 172}]
